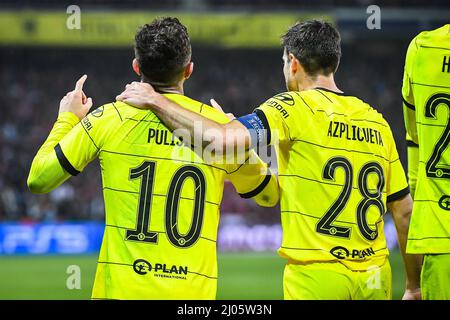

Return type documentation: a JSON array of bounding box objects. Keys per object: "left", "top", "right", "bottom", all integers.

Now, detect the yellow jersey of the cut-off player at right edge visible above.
[{"left": 402, "top": 24, "right": 450, "bottom": 254}]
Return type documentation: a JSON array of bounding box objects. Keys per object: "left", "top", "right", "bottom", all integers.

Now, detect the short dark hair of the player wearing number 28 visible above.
[{"left": 282, "top": 20, "right": 341, "bottom": 76}]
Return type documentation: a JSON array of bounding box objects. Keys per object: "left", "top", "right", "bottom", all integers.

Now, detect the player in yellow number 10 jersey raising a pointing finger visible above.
[{"left": 28, "top": 18, "right": 278, "bottom": 299}]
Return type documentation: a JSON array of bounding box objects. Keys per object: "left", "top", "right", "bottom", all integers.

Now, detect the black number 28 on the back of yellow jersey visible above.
[{"left": 316, "top": 157, "right": 385, "bottom": 240}]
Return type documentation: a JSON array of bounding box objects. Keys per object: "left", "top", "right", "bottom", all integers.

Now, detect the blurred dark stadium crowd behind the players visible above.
[{"left": 0, "top": 34, "right": 408, "bottom": 223}]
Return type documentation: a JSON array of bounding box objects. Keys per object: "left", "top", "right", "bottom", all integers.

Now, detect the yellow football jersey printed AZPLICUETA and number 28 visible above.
[{"left": 251, "top": 88, "right": 409, "bottom": 270}]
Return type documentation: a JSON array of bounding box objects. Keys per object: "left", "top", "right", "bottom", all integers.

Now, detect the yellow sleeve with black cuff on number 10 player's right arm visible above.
[{"left": 227, "top": 150, "right": 279, "bottom": 207}]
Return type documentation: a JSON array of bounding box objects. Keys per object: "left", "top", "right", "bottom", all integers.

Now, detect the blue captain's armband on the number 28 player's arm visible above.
[{"left": 236, "top": 110, "right": 270, "bottom": 149}]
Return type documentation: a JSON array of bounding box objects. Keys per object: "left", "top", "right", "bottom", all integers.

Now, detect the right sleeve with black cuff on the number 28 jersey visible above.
[{"left": 386, "top": 129, "right": 410, "bottom": 202}]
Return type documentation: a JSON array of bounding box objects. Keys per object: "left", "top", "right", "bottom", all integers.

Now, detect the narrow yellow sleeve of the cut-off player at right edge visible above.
[{"left": 402, "top": 38, "right": 418, "bottom": 143}]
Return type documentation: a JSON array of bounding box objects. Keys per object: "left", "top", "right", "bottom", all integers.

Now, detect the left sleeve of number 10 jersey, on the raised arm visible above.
[{"left": 55, "top": 105, "right": 117, "bottom": 176}]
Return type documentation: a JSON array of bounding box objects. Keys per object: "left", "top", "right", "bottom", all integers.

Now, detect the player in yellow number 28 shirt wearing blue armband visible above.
[{"left": 118, "top": 21, "right": 420, "bottom": 299}]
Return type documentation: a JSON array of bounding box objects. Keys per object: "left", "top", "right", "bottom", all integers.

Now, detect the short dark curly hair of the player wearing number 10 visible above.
[{"left": 135, "top": 17, "right": 191, "bottom": 84}]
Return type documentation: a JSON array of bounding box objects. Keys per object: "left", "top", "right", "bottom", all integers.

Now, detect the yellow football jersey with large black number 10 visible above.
[{"left": 55, "top": 94, "right": 276, "bottom": 299}]
